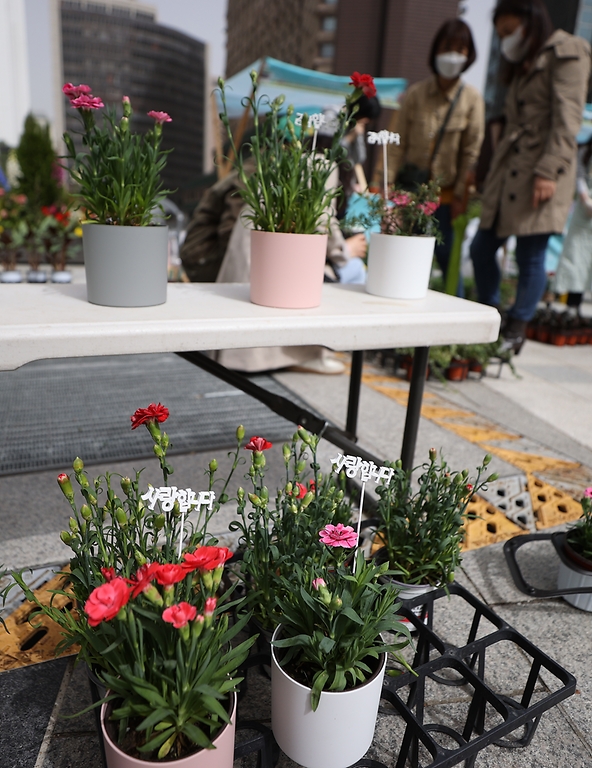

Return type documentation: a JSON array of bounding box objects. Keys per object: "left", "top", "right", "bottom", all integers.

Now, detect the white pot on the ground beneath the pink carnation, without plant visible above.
[{"left": 271, "top": 626, "right": 386, "bottom": 768}]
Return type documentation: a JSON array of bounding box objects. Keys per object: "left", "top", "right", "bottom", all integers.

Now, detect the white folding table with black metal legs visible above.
[{"left": 0, "top": 283, "right": 500, "bottom": 467}]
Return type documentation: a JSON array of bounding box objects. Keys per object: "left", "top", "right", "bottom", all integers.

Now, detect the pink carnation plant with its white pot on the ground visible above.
[{"left": 271, "top": 540, "right": 409, "bottom": 768}]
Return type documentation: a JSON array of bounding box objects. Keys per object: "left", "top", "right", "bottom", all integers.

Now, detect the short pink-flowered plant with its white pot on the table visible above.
[{"left": 366, "top": 181, "right": 440, "bottom": 299}]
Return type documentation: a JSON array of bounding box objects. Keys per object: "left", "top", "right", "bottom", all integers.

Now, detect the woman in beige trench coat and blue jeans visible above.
[{"left": 471, "top": 0, "right": 590, "bottom": 352}]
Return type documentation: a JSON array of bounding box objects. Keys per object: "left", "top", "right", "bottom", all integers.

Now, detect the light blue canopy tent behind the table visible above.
[{"left": 216, "top": 56, "right": 407, "bottom": 118}]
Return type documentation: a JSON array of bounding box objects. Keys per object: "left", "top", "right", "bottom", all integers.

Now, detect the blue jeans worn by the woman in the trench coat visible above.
[{"left": 471, "top": 229, "right": 551, "bottom": 322}]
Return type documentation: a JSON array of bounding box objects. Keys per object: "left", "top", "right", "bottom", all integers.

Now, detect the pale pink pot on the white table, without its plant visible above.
[{"left": 251, "top": 230, "right": 327, "bottom": 309}]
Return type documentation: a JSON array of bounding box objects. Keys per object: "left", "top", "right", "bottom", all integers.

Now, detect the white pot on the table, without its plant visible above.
[{"left": 366, "top": 232, "right": 436, "bottom": 299}]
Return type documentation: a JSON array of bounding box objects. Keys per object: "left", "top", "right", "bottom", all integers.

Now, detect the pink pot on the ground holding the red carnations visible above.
[{"left": 101, "top": 693, "right": 237, "bottom": 768}]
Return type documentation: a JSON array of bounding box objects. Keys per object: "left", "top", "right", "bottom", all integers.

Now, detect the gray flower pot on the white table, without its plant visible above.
[{"left": 82, "top": 224, "right": 169, "bottom": 307}]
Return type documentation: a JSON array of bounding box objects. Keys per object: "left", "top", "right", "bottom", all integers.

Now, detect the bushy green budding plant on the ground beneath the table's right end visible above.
[{"left": 376, "top": 448, "right": 497, "bottom": 599}]
